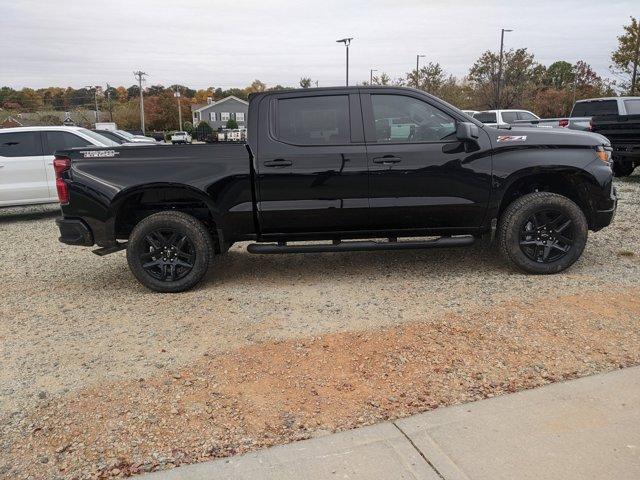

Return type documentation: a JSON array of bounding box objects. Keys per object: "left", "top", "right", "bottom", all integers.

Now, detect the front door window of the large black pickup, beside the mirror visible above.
[{"left": 371, "top": 95, "right": 456, "bottom": 143}]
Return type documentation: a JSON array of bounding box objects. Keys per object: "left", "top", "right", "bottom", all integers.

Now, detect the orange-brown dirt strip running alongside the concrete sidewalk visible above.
[{"left": 0, "top": 289, "right": 640, "bottom": 478}]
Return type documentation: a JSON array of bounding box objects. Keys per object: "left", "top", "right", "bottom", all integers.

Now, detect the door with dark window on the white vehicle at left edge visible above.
[{"left": 0, "top": 131, "right": 50, "bottom": 206}]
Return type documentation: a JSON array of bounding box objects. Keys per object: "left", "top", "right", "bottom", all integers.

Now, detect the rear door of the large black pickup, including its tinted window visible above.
[{"left": 256, "top": 90, "right": 369, "bottom": 235}]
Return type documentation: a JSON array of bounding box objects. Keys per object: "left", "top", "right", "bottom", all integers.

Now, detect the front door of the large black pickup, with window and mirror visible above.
[{"left": 361, "top": 89, "right": 491, "bottom": 230}]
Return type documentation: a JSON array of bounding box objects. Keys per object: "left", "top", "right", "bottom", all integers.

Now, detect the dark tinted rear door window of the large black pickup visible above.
[{"left": 277, "top": 95, "right": 351, "bottom": 145}]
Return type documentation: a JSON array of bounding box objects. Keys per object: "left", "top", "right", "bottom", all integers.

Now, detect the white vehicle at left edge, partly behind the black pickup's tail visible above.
[{"left": 0, "top": 127, "right": 118, "bottom": 207}]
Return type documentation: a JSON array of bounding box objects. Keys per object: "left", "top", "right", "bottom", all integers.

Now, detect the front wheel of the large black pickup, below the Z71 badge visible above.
[{"left": 498, "top": 192, "right": 589, "bottom": 274}]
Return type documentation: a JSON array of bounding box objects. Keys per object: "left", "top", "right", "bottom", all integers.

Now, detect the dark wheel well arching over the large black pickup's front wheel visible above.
[{"left": 498, "top": 173, "right": 591, "bottom": 224}]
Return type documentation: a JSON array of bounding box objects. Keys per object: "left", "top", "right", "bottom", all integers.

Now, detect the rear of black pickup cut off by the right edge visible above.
[{"left": 591, "top": 113, "right": 640, "bottom": 177}]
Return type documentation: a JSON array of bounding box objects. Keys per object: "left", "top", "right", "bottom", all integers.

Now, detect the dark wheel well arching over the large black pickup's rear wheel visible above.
[{"left": 115, "top": 187, "right": 220, "bottom": 253}]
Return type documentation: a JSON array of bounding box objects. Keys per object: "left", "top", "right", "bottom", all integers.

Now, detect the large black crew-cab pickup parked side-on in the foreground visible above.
[{"left": 55, "top": 87, "right": 617, "bottom": 292}]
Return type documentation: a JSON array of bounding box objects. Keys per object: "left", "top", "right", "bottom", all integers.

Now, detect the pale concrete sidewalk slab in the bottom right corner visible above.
[{"left": 143, "top": 367, "right": 640, "bottom": 480}]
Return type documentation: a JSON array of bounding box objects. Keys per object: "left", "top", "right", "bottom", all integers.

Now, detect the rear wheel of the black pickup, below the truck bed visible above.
[{"left": 127, "top": 211, "right": 213, "bottom": 293}]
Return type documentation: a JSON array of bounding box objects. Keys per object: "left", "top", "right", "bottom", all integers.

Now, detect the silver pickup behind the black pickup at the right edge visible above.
[{"left": 512, "top": 97, "right": 640, "bottom": 130}]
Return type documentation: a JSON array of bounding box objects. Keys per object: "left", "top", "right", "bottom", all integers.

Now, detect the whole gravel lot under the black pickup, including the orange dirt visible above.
[{"left": 0, "top": 176, "right": 640, "bottom": 478}]
